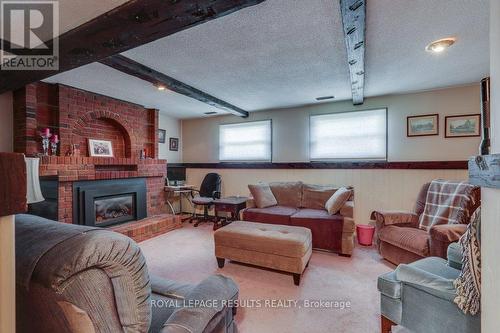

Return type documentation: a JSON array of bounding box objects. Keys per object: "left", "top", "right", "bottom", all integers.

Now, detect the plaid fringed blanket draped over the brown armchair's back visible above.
[{"left": 419, "top": 179, "right": 476, "bottom": 231}]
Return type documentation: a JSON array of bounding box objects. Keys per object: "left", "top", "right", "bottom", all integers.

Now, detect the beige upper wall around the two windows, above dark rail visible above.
[{"left": 182, "top": 84, "right": 480, "bottom": 163}]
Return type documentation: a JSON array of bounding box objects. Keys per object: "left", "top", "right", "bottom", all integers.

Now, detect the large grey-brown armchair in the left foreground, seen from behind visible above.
[{"left": 16, "top": 215, "right": 238, "bottom": 333}]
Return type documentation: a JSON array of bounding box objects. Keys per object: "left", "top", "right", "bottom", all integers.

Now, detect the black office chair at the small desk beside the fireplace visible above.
[{"left": 189, "top": 173, "right": 222, "bottom": 227}]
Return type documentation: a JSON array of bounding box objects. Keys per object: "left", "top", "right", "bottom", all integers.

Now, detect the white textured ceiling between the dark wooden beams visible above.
[{"left": 48, "top": 0, "right": 489, "bottom": 118}]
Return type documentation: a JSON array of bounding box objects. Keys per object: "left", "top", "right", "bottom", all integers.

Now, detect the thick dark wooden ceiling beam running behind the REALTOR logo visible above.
[{"left": 0, "top": 0, "right": 265, "bottom": 93}]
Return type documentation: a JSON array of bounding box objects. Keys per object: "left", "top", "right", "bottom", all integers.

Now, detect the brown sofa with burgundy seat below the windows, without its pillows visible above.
[{"left": 241, "top": 182, "right": 354, "bottom": 256}]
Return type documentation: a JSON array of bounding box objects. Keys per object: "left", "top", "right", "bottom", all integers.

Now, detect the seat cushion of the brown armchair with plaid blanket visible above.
[{"left": 378, "top": 225, "right": 429, "bottom": 257}]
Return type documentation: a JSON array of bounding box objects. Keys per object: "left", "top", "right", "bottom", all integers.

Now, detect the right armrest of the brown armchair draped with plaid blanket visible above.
[{"left": 429, "top": 224, "right": 467, "bottom": 259}]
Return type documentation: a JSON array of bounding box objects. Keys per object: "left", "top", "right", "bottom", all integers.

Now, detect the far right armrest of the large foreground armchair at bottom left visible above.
[{"left": 161, "top": 275, "right": 238, "bottom": 333}]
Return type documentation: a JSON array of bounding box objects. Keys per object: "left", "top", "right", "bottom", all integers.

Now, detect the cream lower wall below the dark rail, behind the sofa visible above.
[{"left": 186, "top": 169, "right": 467, "bottom": 224}]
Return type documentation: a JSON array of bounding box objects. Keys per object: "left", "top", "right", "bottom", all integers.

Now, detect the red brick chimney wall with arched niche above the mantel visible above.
[{"left": 14, "top": 82, "right": 158, "bottom": 158}]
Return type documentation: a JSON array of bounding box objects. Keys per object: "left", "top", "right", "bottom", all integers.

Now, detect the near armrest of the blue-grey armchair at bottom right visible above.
[{"left": 395, "top": 264, "right": 456, "bottom": 302}]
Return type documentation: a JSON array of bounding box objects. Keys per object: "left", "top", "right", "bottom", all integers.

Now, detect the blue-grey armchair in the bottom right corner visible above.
[{"left": 378, "top": 243, "right": 481, "bottom": 333}]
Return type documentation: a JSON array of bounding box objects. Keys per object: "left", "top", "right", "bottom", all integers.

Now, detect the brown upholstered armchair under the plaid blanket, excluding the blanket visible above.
[{"left": 371, "top": 183, "right": 481, "bottom": 265}]
